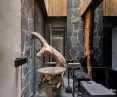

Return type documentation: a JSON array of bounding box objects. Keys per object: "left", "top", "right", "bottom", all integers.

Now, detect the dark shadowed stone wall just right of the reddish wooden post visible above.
[{"left": 92, "top": 4, "right": 103, "bottom": 66}]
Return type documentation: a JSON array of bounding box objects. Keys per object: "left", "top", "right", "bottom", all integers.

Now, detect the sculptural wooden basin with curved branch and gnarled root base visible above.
[{"left": 31, "top": 32, "right": 67, "bottom": 97}]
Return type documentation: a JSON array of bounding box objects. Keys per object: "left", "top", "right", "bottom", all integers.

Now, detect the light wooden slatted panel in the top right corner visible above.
[{"left": 103, "top": 0, "right": 117, "bottom": 16}]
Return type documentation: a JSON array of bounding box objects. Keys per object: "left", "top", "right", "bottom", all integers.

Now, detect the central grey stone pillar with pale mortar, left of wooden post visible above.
[{"left": 67, "top": 0, "right": 84, "bottom": 61}]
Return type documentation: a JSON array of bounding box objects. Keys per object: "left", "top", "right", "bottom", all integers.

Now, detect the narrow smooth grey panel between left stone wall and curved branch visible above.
[{"left": 34, "top": 1, "right": 44, "bottom": 90}]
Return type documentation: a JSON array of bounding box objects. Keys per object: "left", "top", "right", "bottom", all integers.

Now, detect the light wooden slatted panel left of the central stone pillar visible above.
[{"left": 44, "top": 0, "right": 67, "bottom": 16}]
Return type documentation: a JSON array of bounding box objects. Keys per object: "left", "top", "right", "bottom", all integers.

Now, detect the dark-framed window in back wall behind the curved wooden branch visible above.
[{"left": 49, "top": 27, "right": 65, "bottom": 62}]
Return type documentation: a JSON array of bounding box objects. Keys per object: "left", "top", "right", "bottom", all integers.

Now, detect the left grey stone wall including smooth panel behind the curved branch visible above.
[{"left": 21, "top": 0, "right": 44, "bottom": 97}]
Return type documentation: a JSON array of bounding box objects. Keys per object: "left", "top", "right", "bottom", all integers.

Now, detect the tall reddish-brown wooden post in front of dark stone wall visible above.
[{"left": 84, "top": 8, "right": 93, "bottom": 79}]
